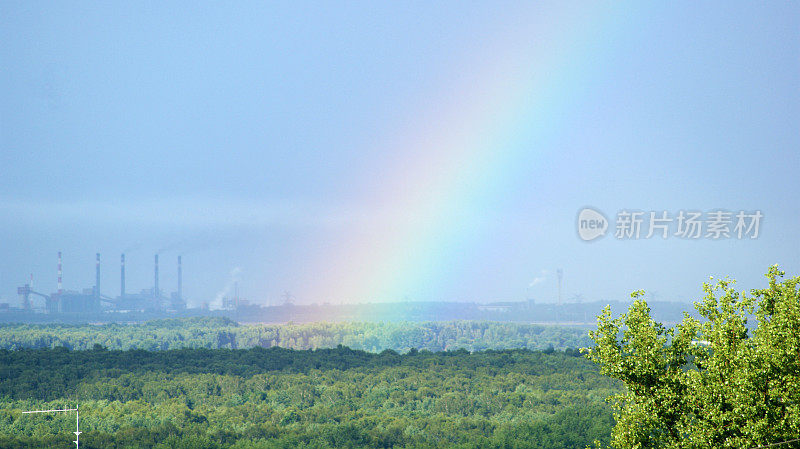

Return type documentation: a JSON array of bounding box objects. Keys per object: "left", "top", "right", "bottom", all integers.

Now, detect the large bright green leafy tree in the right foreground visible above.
[{"left": 583, "top": 266, "right": 800, "bottom": 449}]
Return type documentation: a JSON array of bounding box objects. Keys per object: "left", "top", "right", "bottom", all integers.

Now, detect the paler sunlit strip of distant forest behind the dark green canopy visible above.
[{"left": 0, "top": 317, "right": 592, "bottom": 352}]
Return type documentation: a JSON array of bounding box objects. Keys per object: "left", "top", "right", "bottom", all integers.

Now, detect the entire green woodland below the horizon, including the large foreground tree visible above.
[{"left": 0, "top": 266, "right": 800, "bottom": 449}]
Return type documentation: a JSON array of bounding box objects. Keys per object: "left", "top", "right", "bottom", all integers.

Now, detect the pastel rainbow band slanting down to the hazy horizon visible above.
[{"left": 304, "top": 3, "right": 630, "bottom": 302}]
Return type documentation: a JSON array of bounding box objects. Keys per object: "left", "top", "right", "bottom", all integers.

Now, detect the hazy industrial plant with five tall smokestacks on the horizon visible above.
[{"left": 12, "top": 251, "right": 186, "bottom": 314}]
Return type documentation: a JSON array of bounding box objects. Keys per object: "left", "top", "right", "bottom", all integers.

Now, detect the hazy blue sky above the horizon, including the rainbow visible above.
[{"left": 0, "top": 1, "right": 800, "bottom": 304}]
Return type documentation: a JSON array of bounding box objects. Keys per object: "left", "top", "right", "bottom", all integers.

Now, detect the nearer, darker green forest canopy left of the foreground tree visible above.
[{"left": 0, "top": 347, "right": 621, "bottom": 449}]
